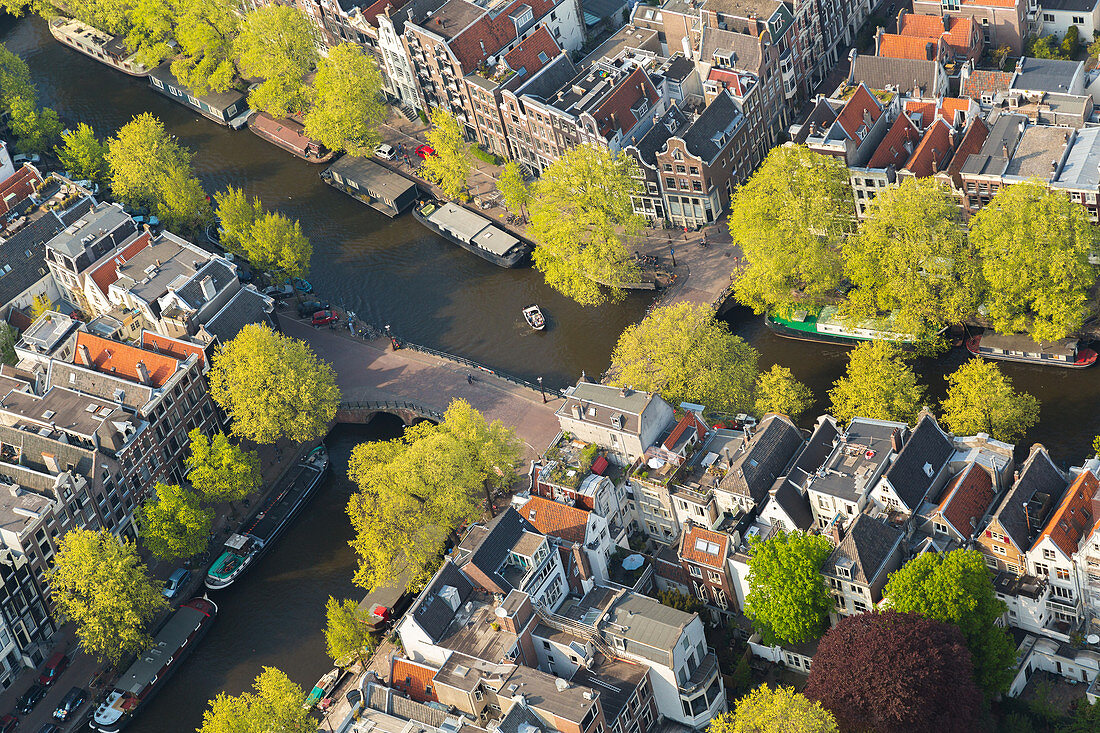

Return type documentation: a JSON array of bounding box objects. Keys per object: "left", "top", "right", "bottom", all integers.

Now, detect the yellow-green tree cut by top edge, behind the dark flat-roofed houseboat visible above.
[{"left": 172, "top": 0, "right": 242, "bottom": 95}]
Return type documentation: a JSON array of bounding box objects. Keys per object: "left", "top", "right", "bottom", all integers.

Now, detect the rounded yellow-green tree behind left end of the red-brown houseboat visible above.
[{"left": 234, "top": 4, "right": 318, "bottom": 118}]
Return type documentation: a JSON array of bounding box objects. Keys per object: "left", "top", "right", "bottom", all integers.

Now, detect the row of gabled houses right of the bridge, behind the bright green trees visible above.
[{"left": 516, "top": 380, "right": 1100, "bottom": 698}]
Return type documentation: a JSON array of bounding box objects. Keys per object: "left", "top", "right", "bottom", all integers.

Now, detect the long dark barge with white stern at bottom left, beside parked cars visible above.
[{"left": 88, "top": 597, "right": 218, "bottom": 733}]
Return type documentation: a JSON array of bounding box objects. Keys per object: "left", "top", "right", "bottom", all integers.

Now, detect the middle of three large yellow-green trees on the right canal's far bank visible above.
[{"left": 844, "top": 177, "right": 980, "bottom": 340}]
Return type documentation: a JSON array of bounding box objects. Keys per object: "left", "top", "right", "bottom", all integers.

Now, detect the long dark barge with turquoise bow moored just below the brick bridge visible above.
[{"left": 206, "top": 446, "right": 329, "bottom": 590}]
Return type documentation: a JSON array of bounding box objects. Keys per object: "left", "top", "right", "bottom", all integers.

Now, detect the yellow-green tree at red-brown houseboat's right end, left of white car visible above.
[{"left": 306, "top": 43, "right": 387, "bottom": 157}]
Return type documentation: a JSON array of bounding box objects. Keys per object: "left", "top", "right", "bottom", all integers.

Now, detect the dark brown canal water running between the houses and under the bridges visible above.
[{"left": 0, "top": 11, "right": 1100, "bottom": 733}]
